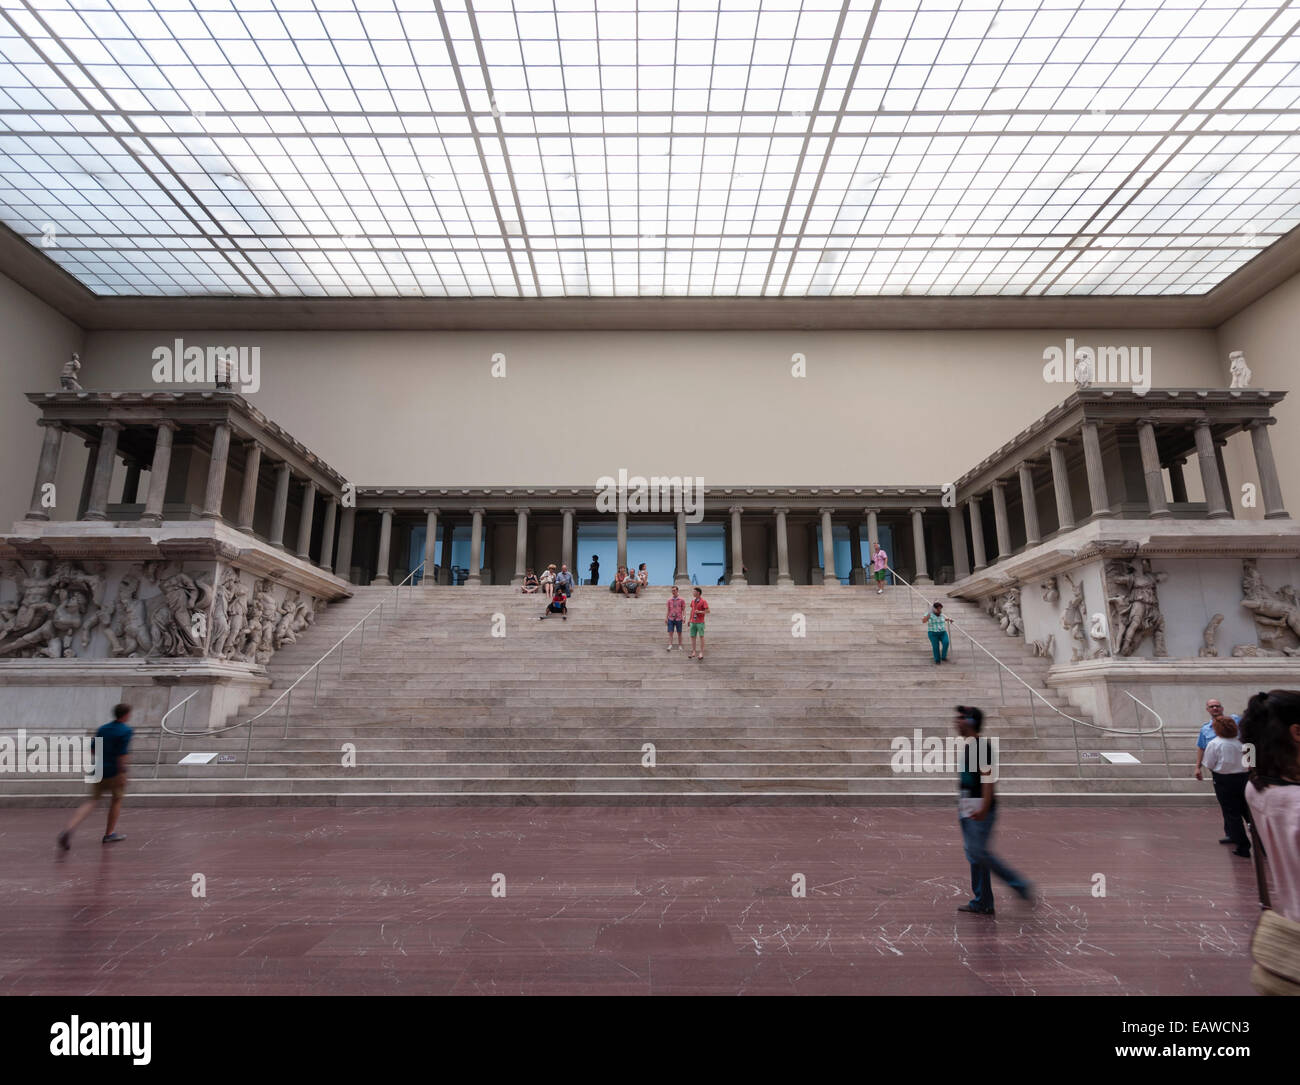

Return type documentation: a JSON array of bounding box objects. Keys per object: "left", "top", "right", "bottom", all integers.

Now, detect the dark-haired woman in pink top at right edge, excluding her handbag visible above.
[{"left": 1242, "top": 690, "right": 1300, "bottom": 923}]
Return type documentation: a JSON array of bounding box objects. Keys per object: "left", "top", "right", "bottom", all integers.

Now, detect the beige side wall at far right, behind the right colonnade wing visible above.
[{"left": 1216, "top": 275, "right": 1300, "bottom": 518}]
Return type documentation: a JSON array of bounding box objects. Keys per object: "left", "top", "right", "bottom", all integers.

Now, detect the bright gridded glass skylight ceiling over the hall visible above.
[{"left": 0, "top": 0, "right": 1300, "bottom": 298}]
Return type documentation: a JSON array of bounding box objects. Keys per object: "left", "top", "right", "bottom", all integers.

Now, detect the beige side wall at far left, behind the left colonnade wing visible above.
[{"left": 0, "top": 275, "right": 86, "bottom": 531}]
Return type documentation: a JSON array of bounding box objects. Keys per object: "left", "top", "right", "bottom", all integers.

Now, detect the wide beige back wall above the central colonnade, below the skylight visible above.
[{"left": 86, "top": 330, "right": 1222, "bottom": 486}]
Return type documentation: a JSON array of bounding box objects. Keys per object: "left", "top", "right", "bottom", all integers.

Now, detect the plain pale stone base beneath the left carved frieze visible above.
[{"left": 0, "top": 659, "right": 270, "bottom": 733}]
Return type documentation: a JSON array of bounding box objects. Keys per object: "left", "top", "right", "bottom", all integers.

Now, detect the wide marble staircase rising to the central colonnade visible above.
[{"left": 0, "top": 586, "right": 1213, "bottom": 806}]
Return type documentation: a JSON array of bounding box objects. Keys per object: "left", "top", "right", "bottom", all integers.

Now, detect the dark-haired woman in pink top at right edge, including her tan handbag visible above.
[{"left": 1242, "top": 690, "right": 1300, "bottom": 995}]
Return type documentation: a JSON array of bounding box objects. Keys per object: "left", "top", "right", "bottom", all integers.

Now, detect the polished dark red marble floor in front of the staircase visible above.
[{"left": 0, "top": 804, "right": 1258, "bottom": 994}]
